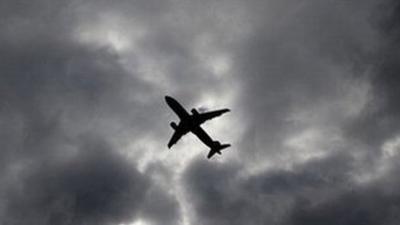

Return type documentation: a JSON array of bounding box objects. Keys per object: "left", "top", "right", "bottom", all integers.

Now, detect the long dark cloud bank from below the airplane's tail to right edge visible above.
[{"left": 184, "top": 155, "right": 400, "bottom": 225}]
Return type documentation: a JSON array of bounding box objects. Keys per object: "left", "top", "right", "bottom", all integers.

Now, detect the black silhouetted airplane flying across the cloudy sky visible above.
[{"left": 165, "top": 96, "right": 231, "bottom": 158}]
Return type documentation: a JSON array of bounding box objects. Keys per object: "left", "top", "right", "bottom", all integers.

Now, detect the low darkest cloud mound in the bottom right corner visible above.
[{"left": 291, "top": 188, "right": 399, "bottom": 225}]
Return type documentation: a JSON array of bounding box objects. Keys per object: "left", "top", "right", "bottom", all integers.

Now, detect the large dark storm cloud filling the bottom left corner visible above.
[{"left": 1, "top": 138, "right": 150, "bottom": 224}]
